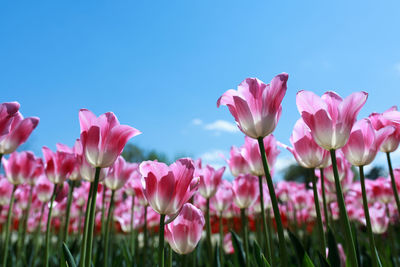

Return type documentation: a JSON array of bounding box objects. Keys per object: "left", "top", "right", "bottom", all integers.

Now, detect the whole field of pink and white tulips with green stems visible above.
[{"left": 0, "top": 73, "right": 400, "bottom": 267}]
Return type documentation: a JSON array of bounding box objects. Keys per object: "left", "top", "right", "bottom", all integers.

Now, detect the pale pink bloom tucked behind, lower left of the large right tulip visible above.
[{"left": 282, "top": 118, "right": 330, "bottom": 168}]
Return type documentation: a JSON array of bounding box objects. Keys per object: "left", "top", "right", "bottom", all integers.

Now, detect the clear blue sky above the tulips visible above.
[{"left": 0, "top": 1, "right": 400, "bottom": 179}]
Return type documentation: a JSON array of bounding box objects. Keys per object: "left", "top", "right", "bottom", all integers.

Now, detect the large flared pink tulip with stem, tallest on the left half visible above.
[{"left": 79, "top": 109, "right": 141, "bottom": 267}]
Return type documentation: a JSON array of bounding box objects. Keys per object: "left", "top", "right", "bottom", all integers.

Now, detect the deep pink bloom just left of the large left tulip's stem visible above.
[{"left": 42, "top": 146, "right": 76, "bottom": 184}]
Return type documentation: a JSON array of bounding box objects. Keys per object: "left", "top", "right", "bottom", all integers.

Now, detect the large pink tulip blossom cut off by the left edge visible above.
[{"left": 0, "top": 102, "right": 39, "bottom": 155}]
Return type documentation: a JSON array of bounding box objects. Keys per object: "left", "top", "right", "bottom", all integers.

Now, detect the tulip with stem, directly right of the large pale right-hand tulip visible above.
[{"left": 342, "top": 119, "right": 395, "bottom": 266}]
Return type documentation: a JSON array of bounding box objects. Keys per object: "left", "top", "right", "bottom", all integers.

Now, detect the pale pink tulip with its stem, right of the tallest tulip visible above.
[{"left": 296, "top": 91, "right": 368, "bottom": 266}]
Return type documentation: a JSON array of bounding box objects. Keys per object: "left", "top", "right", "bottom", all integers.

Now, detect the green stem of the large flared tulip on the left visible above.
[{"left": 85, "top": 167, "right": 101, "bottom": 267}]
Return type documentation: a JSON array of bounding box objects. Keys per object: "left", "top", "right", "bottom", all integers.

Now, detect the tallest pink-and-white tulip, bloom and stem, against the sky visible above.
[{"left": 217, "top": 73, "right": 289, "bottom": 266}]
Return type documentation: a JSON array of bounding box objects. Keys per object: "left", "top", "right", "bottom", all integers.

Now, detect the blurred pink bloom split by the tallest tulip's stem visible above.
[{"left": 242, "top": 135, "right": 280, "bottom": 176}]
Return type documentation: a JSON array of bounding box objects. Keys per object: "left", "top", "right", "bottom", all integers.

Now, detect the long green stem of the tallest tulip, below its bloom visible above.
[{"left": 257, "top": 137, "right": 288, "bottom": 267}]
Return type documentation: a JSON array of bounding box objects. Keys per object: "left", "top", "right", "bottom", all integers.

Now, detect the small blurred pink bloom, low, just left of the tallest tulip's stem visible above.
[{"left": 232, "top": 174, "right": 259, "bottom": 209}]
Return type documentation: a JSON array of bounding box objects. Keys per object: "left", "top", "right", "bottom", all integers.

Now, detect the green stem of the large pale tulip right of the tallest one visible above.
[{"left": 330, "top": 149, "right": 359, "bottom": 267}]
